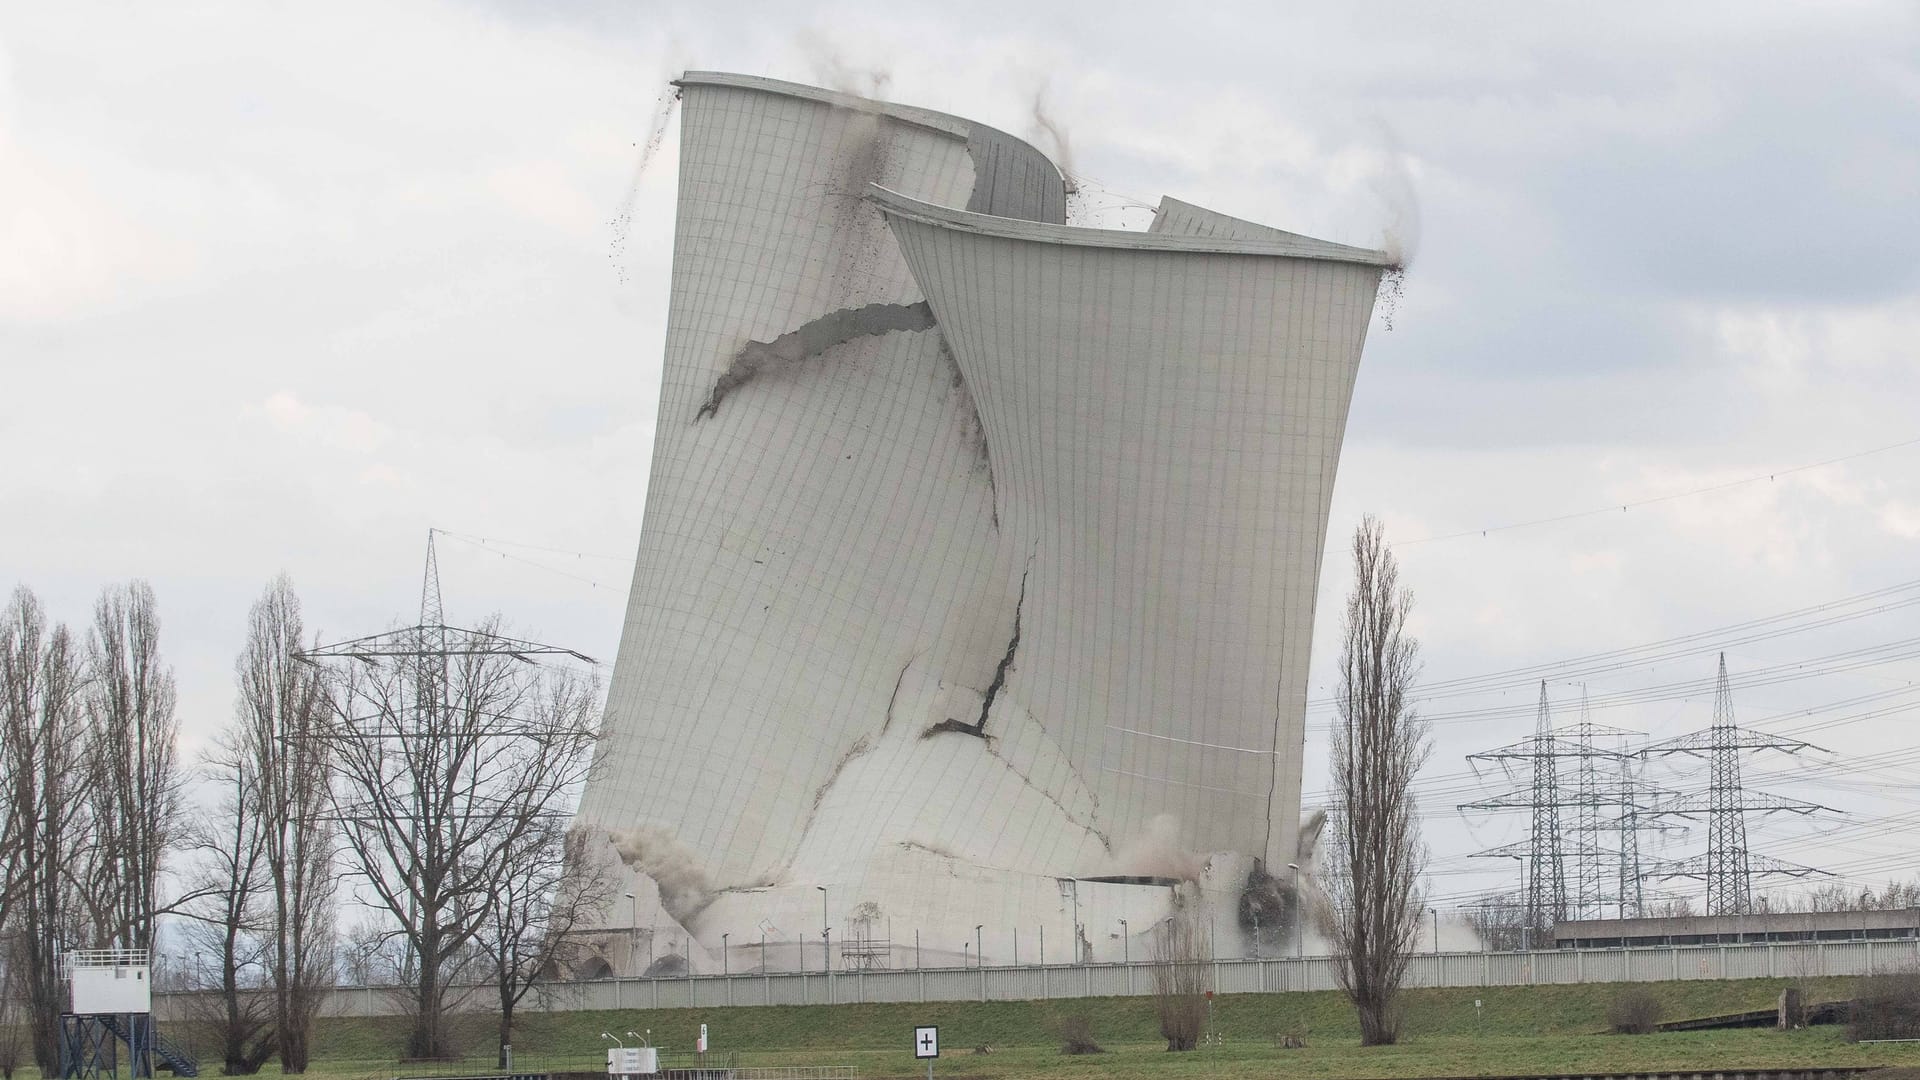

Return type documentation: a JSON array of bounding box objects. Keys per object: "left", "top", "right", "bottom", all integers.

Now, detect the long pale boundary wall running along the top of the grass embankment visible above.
[{"left": 156, "top": 940, "right": 1920, "bottom": 1017}]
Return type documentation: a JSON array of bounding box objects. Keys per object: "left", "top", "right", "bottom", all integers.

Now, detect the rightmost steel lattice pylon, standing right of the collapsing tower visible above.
[{"left": 1642, "top": 653, "right": 1832, "bottom": 915}]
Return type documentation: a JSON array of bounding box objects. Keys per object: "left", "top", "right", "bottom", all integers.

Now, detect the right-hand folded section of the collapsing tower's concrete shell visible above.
[{"left": 870, "top": 188, "right": 1384, "bottom": 865}]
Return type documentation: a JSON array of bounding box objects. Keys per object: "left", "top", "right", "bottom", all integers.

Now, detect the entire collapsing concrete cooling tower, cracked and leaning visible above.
[{"left": 560, "top": 73, "right": 1388, "bottom": 970}]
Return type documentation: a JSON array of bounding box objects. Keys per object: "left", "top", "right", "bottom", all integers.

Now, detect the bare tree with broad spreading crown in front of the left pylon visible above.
[{"left": 318, "top": 619, "right": 597, "bottom": 1059}]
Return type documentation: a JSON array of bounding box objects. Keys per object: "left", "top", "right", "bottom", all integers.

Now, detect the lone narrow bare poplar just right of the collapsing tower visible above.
[{"left": 1327, "top": 517, "right": 1430, "bottom": 1045}]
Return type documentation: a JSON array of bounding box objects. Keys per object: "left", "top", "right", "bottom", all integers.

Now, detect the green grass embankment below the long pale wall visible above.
[{"left": 269, "top": 978, "right": 1920, "bottom": 1080}]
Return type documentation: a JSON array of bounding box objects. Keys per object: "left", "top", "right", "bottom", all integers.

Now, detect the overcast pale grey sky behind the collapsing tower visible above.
[{"left": 0, "top": 0, "right": 1920, "bottom": 897}]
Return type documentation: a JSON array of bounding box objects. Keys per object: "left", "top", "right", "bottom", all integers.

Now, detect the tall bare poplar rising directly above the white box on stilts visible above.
[{"left": 77, "top": 580, "right": 180, "bottom": 949}]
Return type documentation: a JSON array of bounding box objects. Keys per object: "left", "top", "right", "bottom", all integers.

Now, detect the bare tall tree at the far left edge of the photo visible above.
[{"left": 0, "top": 588, "right": 92, "bottom": 1072}]
